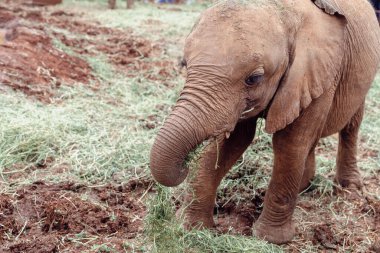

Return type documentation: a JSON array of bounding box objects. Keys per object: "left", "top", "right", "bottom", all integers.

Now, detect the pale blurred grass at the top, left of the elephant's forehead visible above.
[{"left": 63, "top": 0, "right": 211, "bottom": 43}]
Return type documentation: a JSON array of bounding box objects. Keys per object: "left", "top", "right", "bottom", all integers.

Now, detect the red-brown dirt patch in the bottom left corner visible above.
[{"left": 0, "top": 181, "right": 147, "bottom": 252}]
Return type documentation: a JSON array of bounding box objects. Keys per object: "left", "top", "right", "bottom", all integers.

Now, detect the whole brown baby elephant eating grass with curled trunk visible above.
[{"left": 150, "top": 0, "right": 380, "bottom": 244}]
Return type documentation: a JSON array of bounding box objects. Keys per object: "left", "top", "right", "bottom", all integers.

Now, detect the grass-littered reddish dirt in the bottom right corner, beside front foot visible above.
[{"left": 286, "top": 176, "right": 380, "bottom": 252}]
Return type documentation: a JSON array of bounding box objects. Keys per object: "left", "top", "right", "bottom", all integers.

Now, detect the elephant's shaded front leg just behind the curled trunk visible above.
[{"left": 184, "top": 119, "right": 256, "bottom": 228}]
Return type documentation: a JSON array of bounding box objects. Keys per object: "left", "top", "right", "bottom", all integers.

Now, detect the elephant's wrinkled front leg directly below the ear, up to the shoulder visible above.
[{"left": 254, "top": 96, "right": 332, "bottom": 244}]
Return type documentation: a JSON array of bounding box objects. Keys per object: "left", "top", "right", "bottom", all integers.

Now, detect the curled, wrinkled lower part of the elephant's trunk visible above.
[{"left": 150, "top": 105, "right": 210, "bottom": 186}]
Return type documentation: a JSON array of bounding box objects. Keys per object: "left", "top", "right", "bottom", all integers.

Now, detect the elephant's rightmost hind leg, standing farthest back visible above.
[{"left": 335, "top": 104, "right": 364, "bottom": 190}]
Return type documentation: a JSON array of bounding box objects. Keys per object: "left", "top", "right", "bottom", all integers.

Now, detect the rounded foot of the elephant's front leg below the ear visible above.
[{"left": 253, "top": 218, "right": 296, "bottom": 244}]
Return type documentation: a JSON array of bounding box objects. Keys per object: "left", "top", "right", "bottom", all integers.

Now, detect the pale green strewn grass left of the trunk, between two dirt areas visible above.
[{"left": 0, "top": 58, "right": 183, "bottom": 187}]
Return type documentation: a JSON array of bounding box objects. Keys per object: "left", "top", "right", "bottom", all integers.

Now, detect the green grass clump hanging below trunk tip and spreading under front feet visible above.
[{"left": 145, "top": 185, "right": 282, "bottom": 253}]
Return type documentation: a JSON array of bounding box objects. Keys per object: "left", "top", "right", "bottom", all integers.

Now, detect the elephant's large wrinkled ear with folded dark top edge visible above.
[{"left": 265, "top": 0, "right": 347, "bottom": 133}]
